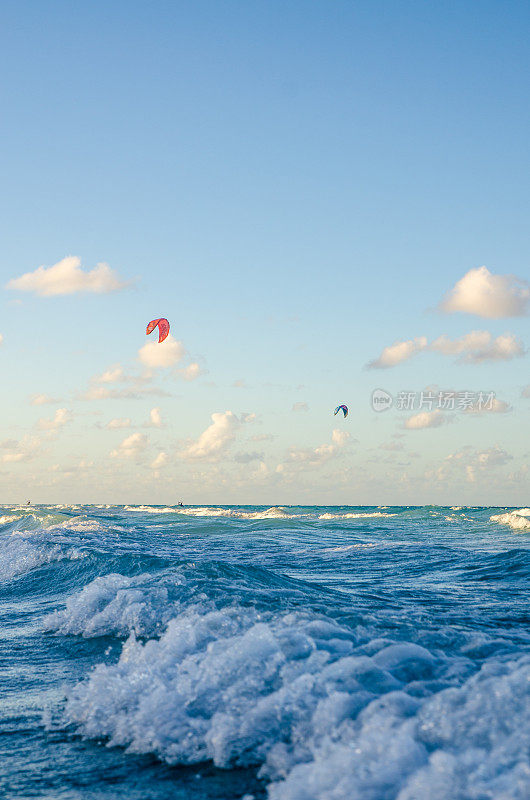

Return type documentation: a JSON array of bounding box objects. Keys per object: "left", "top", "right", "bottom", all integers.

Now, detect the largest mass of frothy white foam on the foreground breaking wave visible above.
[{"left": 66, "top": 587, "right": 530, "bottom": 800}]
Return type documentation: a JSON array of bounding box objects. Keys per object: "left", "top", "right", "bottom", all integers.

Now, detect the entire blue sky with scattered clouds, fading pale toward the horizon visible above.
[{"left": 0, "top": 0, "right": 530, "bottom": 505}]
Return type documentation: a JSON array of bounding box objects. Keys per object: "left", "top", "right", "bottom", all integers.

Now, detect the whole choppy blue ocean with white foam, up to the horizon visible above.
[{"left": 0, "top": 505, "right": 530, "bottom": 800}]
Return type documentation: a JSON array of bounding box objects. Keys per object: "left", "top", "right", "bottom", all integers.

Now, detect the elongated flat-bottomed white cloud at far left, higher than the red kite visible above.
[{"left": 6, "top": 256, "right": 128, "bottom": 297}]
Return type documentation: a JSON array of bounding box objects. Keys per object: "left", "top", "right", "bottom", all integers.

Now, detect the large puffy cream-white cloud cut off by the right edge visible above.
[{"left": 440, "top": 267, "right": 530, "bottom": 319}]
